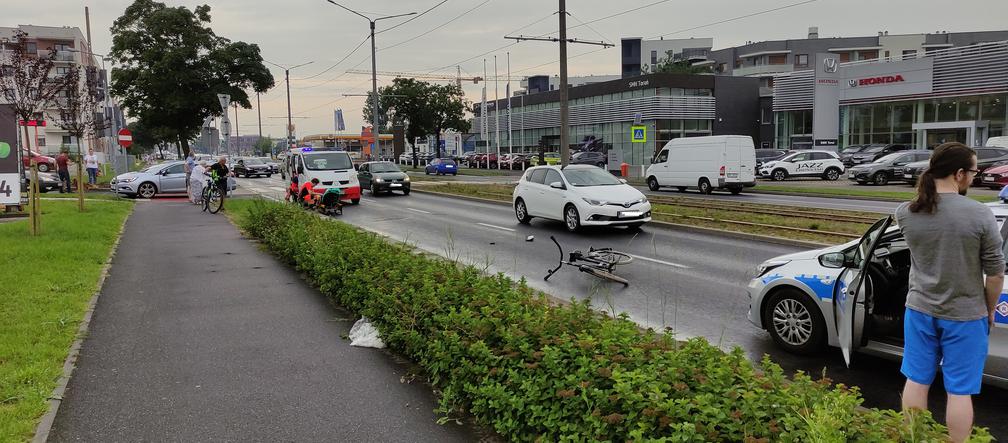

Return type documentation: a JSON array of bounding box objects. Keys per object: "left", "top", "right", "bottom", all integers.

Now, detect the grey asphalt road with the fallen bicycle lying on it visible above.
[{"left": 241, "top": 179, "right": 1008, "bottom": 438}]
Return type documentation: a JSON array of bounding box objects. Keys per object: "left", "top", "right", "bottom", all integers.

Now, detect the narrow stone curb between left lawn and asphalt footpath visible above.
[{"left": 31, "top": 205, "right": 132, "bottom": 443}]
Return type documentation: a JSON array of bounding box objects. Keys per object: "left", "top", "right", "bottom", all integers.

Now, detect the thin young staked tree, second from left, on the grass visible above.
[{"left": 49, "top": 67, "right": 107, "bottom": 211}]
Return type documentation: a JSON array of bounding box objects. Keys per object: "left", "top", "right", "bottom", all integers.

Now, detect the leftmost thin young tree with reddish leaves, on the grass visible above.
[{"left": 0, "top": 31, "right": 69, "bottom": 235}]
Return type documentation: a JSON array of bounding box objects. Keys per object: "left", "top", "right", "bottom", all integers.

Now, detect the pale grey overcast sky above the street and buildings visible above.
[{"left": 7, "top": 0, "right": 1008, "bottom": 137}]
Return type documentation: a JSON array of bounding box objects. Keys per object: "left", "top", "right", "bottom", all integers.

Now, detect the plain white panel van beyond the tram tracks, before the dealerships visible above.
[{"left": 644, "top": 135, "right": 756, "bottom": 194}]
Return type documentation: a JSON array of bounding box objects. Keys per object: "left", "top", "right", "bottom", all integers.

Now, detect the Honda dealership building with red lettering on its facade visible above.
[{"left": 773, "top": 41, "right": 1008, "bottom": 148}]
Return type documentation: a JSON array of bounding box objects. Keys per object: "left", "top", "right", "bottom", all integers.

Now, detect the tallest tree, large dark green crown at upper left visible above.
[{"left": 111, "top": 0, "right": 273, "bottom": 153}]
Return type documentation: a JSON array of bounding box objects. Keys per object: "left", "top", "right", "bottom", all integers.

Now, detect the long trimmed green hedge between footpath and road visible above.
[{"left": 240, "top": 202, "right": 989, "bottom": 442}]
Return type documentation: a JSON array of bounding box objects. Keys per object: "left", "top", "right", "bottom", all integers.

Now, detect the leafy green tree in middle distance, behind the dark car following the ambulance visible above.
[{"left": 364, "top": 78, "right": 470, "bottom": 160}]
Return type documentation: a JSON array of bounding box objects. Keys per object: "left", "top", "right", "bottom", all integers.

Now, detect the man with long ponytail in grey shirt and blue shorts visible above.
[{"left": 895, "top": 142, "right": 1005, "bottom": 442}]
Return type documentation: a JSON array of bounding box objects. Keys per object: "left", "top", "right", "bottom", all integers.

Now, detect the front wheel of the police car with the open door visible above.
[{"left": 763, "top": 289, "right": 826, "bottom": 354}]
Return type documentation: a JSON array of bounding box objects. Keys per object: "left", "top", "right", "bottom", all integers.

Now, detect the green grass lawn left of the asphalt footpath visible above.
[{"left": 0, "top": 201, "right": 133, "bottom": 441}]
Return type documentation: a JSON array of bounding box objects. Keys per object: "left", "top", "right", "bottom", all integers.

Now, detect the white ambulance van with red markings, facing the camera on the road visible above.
[{"left": 281, "top": 147, "right": 361, "bottom": 205}]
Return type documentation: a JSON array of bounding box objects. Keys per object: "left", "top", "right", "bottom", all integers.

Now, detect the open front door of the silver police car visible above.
[{"left": 833, "top": 216, "right": 892, "bottom": 366}]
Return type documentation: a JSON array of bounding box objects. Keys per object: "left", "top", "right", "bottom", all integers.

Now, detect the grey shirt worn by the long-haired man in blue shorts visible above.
[{"left": 895, "top": 194, "right": 1005, "bottom": 321}]
